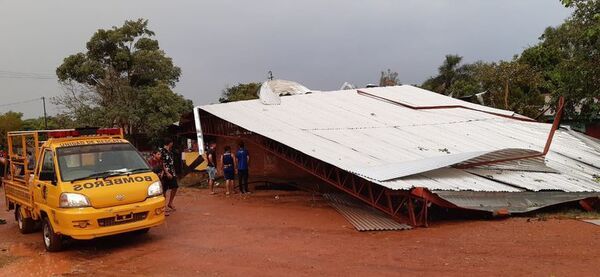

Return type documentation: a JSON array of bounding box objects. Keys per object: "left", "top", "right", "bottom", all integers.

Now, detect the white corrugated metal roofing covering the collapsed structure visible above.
[{"left": 200, "top": 86, "right": 600, "bottom": 191}]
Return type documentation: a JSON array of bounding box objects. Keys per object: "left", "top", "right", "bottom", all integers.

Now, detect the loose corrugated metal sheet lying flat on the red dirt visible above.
[{"left": 323, "top": 193, "right": 412, "bottom": 231}]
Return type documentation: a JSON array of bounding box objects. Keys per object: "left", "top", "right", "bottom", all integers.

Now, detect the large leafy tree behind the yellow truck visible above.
[{"left": 54, "top": 19, "right": 192, "bottom": 135}]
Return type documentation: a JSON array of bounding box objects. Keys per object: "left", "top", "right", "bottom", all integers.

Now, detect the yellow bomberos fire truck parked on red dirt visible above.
[{"left": 4, "top": 128, "right": 165, "bottom": 251}]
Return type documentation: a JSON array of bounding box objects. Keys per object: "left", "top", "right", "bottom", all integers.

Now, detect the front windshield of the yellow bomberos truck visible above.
[{"left": 57, "top": 143, "right": 150, "bottom": 182}]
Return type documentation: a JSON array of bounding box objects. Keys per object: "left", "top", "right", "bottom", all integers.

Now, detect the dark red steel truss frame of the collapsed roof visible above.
[{"left": 195, "top": 97, "right": 564, "bottom": 227}]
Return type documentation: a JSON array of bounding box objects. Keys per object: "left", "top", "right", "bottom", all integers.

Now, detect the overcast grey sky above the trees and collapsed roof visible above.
[{"left": 0, "top": 0, "right": 570, "bottom": 117}]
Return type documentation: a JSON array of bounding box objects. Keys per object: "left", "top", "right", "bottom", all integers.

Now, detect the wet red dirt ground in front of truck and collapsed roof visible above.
[{"left": 0, "top": 188, "right": 600, "bottom": 276}]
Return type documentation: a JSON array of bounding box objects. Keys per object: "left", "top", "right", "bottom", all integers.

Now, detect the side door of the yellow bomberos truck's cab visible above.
[{"left": 34, "top": 149, "right": 59, "bottom": 208}]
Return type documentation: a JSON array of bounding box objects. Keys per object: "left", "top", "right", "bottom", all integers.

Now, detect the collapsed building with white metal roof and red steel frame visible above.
[{"left": 194, "top": 82, "right": 600, "bottom": 226}]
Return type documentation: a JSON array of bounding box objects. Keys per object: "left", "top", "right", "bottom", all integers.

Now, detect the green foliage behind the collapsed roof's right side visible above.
[{"left": 421, "top": 0, "right": 600, "bottom": 122}]
